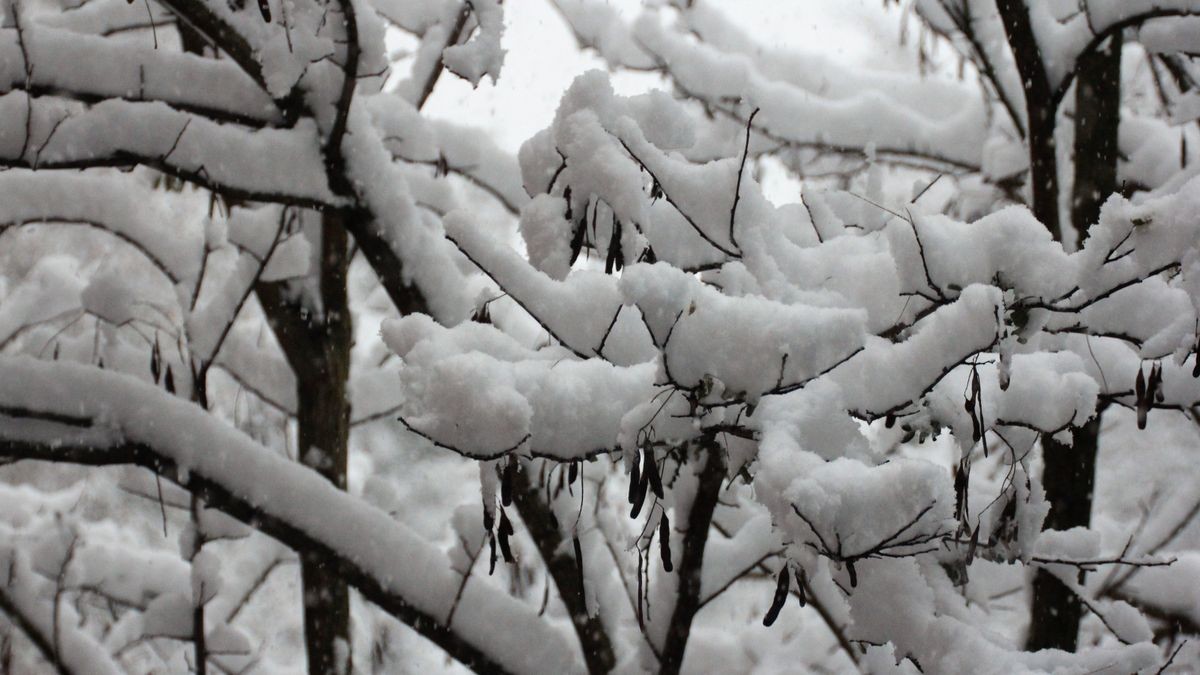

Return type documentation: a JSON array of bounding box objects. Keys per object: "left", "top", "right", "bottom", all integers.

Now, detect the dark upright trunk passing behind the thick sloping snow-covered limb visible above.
[{"left": 258, "top": 210, "right": 352, "bottom": 674}]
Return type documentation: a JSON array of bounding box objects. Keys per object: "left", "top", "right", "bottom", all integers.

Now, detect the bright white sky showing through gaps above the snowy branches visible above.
[{"left": 425, "top": 0, "right": 913, "bottom": 151}]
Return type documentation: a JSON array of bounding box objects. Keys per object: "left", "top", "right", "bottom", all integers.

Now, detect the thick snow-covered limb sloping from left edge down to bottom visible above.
[{"left": 0, "top": 357, "right": 578, "bottom": 673}]
